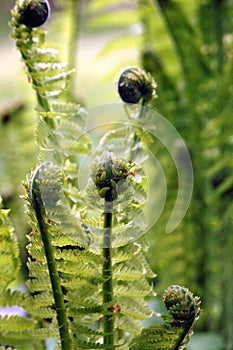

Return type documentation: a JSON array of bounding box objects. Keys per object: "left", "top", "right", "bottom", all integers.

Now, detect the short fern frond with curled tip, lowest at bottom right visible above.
[{"left": 130, "top": 285, "right": 200, "bottom": 350}]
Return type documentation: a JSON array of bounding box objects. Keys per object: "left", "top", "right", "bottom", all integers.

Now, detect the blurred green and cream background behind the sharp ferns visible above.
[{"left": 0, "top": 0, "right": 233, "bottom": 350}]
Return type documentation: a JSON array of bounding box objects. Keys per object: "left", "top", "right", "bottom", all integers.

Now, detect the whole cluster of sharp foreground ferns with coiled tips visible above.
[{"left": 0, "top": 0, "right": 200, "bottom": 350}]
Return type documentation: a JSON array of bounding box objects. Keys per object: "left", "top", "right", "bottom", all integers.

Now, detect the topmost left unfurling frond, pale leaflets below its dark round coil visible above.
[{"left": 11, "top": 0, "right": 90, "bottom": 174}]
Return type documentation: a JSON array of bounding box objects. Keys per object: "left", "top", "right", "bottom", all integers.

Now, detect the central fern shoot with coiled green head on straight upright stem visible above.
[{"left": 95, "top": 154, "right": 139, "bottom": 350}]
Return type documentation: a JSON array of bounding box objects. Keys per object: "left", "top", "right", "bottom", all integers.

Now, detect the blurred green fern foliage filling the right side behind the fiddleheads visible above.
[{"left": 140, "top": 1, "right": 233, "bottom": 349}]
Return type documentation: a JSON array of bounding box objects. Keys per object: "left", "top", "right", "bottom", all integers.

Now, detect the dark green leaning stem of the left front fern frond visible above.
[{"left": 31, "top": 171, "right": 72, "bottom": 350}]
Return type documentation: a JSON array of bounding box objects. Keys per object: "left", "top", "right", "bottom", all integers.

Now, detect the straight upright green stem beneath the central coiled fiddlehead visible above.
[{"left": 103, "top": 158, "right": 114, "bottom": 350}]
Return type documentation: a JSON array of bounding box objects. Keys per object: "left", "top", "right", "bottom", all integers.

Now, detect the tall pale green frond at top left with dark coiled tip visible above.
[{"left": 10, "top": 0, "right": 82, "bottom": 164}]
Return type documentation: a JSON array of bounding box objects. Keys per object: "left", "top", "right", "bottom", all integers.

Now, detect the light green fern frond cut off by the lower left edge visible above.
[{"left": 0, "top": 198, "right": 42, "bottom": 350}]
